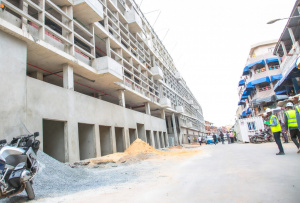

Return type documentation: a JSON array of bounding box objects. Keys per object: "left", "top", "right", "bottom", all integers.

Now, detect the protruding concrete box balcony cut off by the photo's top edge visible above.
[{"left": 73, "top": 0, "right": 104, "bottom": 25}]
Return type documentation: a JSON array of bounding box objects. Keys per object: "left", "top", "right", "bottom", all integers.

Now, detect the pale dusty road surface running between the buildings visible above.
[{"left": 37, "top": 142, "right": 300, "bottom": 203}]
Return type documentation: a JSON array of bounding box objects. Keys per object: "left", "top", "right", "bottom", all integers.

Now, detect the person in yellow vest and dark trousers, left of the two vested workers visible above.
[{"left": 264, "top": 108, "right": 284, "bottom": 155}]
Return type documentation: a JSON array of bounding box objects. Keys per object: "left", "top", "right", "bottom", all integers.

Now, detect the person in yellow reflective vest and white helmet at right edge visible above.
[{"left": 284, "top": 102, "right": 300, "bottom": 153}]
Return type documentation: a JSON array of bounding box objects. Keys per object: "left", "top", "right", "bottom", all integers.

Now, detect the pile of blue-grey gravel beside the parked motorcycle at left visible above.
[{"left": 0, "top": 151, "right": 143, "bottom": 203}]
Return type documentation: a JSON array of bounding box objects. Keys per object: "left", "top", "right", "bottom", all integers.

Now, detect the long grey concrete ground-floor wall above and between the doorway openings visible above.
[{"left": 24, "top": 77, "right": 166, "bottom": 162}]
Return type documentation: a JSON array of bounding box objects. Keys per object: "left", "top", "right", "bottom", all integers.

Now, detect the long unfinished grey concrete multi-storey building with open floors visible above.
[{"left": 0, "top": 0, "right": 205, "bottom": 161}]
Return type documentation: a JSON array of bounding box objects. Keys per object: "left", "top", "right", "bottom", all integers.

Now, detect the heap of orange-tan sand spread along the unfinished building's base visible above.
[{"left": 88, "top": 138, "right": 201, "bottom": 167}]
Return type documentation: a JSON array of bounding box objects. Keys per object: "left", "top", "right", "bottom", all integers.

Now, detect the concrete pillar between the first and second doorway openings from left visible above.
[{"left": 64, "top": 120, "right": 80, "bottom": 162}]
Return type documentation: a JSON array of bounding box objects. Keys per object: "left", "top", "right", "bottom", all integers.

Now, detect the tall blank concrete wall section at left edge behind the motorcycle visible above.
[{"left": 0, "top": 31, "right": 27, "bottom": 140}]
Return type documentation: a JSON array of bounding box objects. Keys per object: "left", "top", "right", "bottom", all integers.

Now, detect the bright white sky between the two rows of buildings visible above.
[{"left": 136, "top": 0, "right": 295, "bottom": 126}]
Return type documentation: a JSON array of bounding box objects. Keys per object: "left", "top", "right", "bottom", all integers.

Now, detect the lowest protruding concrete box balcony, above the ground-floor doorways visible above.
[{"left": 93, "top": 56, "right": 123, "bottom": 82}]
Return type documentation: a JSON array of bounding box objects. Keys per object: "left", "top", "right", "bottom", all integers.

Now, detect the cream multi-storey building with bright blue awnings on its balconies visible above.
[{"left": 236, "top": 40, "right": 287, "bottom": 119}]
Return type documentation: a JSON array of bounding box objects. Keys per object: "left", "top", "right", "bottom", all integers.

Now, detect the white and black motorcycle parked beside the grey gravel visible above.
[{"left": 0, "top": 132, "right": 40, "bottom": 200}]
